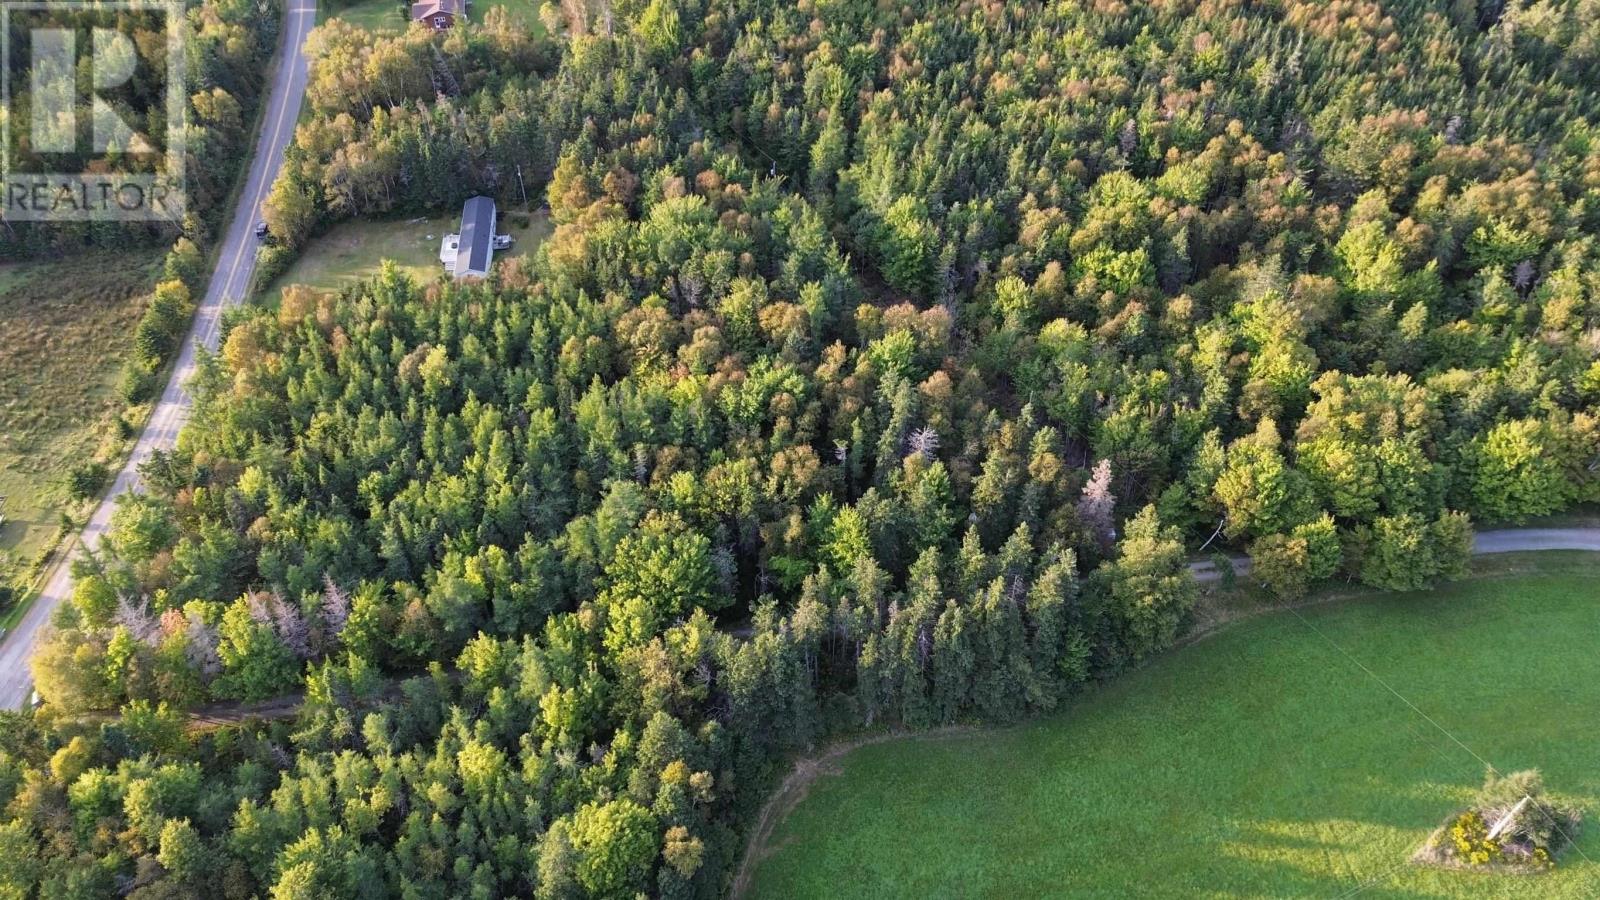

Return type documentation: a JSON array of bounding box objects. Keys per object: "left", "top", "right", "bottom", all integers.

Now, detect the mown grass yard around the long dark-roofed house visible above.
[{"left": 267, "top": 211, "right": 550, "bottom": 296}]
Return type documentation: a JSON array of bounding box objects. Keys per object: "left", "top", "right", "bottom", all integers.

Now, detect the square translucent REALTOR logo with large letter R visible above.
[{"left": 0, "top": 0, "right": 189, "bottom": 223}]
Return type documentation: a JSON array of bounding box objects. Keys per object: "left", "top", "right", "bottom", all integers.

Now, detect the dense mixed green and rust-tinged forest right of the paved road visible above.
[{"left": 0, "top": 0, "right": 1600, "bottom": 898}]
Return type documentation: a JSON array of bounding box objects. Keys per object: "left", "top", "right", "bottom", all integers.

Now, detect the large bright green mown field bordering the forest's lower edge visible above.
[{"left": 749, "top": 554, "right": 1600, "bottom": 898}]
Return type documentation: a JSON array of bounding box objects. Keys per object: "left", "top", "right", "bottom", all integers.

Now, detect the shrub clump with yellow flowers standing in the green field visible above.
[{"left": 1414, "top": 769, "right": 1582, "bottom": 871}]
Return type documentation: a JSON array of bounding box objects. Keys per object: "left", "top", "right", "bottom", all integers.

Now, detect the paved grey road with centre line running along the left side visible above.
[{"left": 0, "top": 0, "right": 317, "bottom": 709}]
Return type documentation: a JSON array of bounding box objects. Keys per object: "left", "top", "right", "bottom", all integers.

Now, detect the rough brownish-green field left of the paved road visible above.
[{"left": 0, "top": 250, "right": 162, "bottom": 564}]
